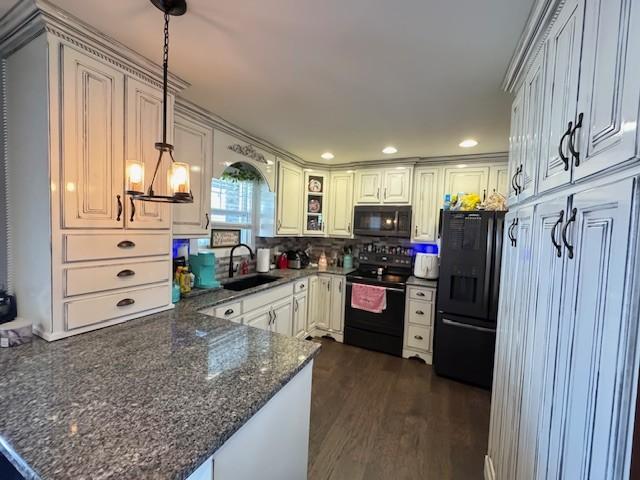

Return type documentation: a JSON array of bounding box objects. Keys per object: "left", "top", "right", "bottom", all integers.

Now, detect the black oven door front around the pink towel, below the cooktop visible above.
[{"left": 344, "top": 282, "right": 405, "bottom": 356}]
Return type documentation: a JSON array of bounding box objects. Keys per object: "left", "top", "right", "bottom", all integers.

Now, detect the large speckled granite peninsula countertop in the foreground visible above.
[{"left": 0, "top": 300, "right": 320, "bottom": 480}]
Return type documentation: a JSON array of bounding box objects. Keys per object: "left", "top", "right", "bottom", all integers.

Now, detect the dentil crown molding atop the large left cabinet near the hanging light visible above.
[{"left": 0, "top": 0, "right": 190, "bottom": 93}]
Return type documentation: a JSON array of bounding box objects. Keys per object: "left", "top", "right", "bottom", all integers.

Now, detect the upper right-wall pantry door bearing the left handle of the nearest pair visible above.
[{"left": 538, "top": 0, "right": 584, "bottom": 192}]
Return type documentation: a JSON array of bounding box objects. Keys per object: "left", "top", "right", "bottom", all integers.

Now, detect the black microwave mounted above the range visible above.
[{"left": 353, "top": 205, "right": 411, "bottom": 238}]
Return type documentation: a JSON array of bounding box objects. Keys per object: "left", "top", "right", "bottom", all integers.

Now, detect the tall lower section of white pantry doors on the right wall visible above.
[{"left": 485, "top": 178, "right": 640, "bottom": 479}]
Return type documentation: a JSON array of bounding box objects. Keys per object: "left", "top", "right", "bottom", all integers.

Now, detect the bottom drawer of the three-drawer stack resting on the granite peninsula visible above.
[{"left": 65, "top": 285, "right": 171, "bottom": 330}]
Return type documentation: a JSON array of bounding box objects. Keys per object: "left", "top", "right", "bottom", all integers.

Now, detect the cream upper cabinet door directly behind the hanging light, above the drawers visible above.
[{"left": 125, "top": 78, "right": 172, "bottom": 229}]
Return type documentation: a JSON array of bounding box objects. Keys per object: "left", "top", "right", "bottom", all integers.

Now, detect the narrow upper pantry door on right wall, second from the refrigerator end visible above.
[{"left": 516, "top": 45, "right": 546, "bottom": 200}]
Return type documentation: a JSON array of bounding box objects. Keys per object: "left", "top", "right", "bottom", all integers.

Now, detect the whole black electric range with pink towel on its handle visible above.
[{"left": 344, "top": 253, "right": 413, "bottom": 356}]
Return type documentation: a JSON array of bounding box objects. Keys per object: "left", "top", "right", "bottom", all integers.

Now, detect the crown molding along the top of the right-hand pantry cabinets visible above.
[{"left": 502, "top": 0, "right": 566, "bottom": 93}]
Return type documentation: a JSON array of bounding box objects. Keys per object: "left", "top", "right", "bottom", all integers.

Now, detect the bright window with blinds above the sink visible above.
[{"left": 211, "top": 178, "right": 256, "bottom": 247}]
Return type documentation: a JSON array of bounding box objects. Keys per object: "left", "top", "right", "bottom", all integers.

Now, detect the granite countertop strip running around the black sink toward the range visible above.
[{"left": 181, "top": 267, "right": 356, "bottom": 311}]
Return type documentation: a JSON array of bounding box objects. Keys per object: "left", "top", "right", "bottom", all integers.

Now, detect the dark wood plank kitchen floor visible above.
[{"left": 309, "top": 340, "right": 490, "bottom": 480}]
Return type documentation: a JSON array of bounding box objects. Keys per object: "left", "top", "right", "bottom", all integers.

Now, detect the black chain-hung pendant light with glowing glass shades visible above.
[{"left": 127, "top": 0, "right": 193, "bottom": 203}]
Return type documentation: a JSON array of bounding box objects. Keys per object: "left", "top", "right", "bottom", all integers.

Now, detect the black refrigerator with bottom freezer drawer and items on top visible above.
[{"left": 433, "top": 211, "right": 505, "bottom": 388}]
